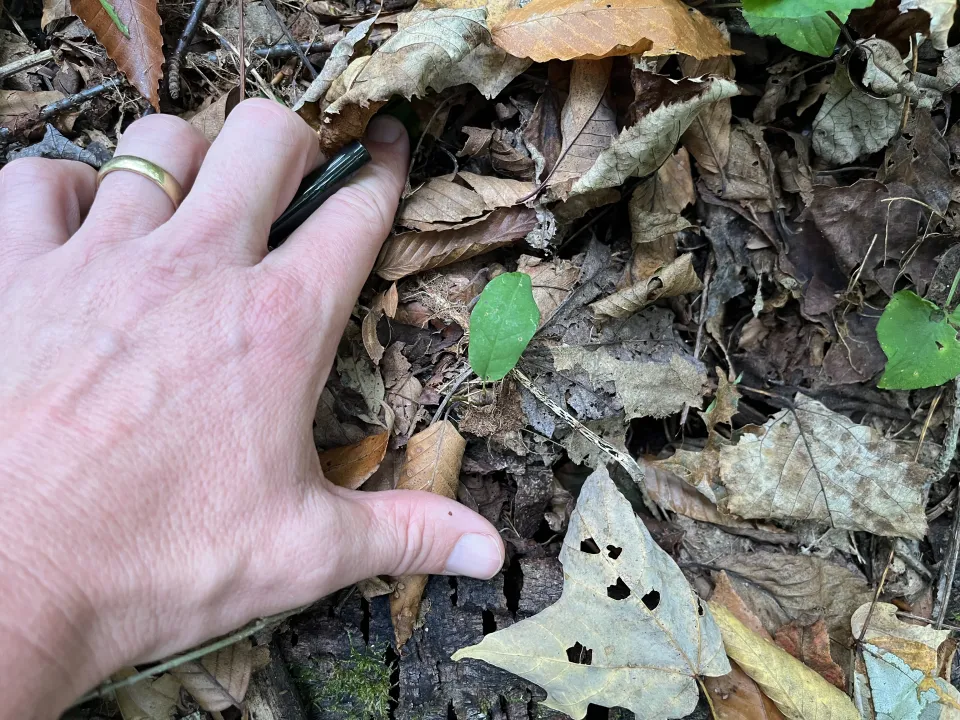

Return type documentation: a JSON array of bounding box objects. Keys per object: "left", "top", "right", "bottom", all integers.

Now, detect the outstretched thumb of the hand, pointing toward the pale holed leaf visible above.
[{"left": 333, "top": 488, "right": 504, "bottom": 584}]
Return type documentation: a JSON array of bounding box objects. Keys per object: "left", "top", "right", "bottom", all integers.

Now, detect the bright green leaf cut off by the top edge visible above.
[{"left": 743, "top": 0, "right": 874, "bottom": 57}]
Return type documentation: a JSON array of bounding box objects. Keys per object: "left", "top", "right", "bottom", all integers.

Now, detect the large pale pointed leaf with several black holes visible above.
[{"left": 453, "top": 465, "right": 730, "bottom": 720}]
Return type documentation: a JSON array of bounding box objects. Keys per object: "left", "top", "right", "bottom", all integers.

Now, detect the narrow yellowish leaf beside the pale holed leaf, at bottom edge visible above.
[{"left": 709, "top": 602, "right": 860, "bottom": 720}]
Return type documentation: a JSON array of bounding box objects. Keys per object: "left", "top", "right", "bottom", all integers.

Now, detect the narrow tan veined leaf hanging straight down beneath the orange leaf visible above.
[{"left": 547, "top": 59, "right": 617, "bottom": 198}]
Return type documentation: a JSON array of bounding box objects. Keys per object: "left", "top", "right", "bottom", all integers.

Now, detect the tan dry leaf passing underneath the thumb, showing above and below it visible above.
[{"left": 390, "top": 420, "right": 467, "bottom": 650}]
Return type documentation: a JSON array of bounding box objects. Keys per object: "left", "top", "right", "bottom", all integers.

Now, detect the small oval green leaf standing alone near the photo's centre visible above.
[{"left": 468, "top": 273, "right": 540, "bottom": 380}]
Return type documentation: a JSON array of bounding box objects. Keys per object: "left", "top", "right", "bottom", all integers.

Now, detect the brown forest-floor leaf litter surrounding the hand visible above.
[{"left": 15, "top": 0, "right": 960, "bottom": 720}]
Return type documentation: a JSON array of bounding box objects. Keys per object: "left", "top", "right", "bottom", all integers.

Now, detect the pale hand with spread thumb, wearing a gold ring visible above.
[{"left": 0, "top": 100, "right": 503, "bottom": 720}]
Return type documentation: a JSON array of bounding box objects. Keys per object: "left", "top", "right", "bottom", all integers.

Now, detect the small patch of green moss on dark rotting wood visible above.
[{"left": 290, "top": 648, "right": 391, "bottom": 720}]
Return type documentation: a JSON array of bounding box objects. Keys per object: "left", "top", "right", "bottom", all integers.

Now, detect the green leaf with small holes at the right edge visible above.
[{"left": 877, "top": 290, "right": 960, "bottom": 390}]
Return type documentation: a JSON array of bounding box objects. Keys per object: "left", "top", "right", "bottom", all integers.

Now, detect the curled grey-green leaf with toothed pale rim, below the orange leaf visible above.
[{"left": 572, "top": 75, "right": 737, "bottom": 195}]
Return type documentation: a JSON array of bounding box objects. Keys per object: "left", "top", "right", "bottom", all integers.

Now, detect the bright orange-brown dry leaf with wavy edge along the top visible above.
[{"left": 490, "top": 0, "right": 733, "bottom": 62}]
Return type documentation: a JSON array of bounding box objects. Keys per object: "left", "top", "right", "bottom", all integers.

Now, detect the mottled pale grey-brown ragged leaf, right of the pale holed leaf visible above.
[{"left": 720, "top": 394, "right": 930, "bottom": 540}]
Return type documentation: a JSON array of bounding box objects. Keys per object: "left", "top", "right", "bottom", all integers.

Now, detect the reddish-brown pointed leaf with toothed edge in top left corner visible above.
[{"left": 71, "top": 0, "right": 163, "bottom": 110}]
